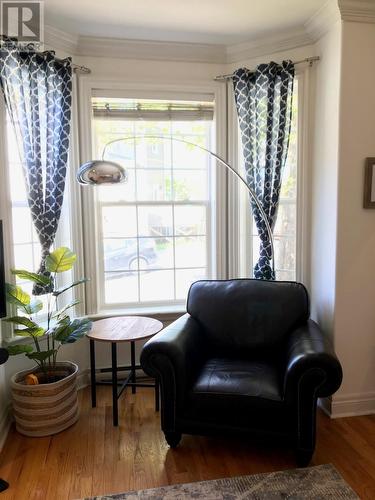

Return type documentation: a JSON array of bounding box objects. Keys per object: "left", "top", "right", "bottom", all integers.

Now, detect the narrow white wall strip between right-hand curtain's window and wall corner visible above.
[{"left": 310, "top": 20, "right": 341, "bottom": 335}]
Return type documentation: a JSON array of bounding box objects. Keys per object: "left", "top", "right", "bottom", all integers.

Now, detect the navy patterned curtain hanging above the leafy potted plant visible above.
[{"left": 0, "top": 41, "right": 72, "bottom": 295}]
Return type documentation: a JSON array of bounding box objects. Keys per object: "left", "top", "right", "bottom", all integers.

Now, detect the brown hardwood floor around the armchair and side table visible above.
[{"left": 0, "top": 387, "right": 375, "bottom": 500}]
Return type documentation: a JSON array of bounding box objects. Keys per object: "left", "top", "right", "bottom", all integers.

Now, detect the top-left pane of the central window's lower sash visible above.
[{"left": 102, "top": 207, "right": 137, "bottom": 237}]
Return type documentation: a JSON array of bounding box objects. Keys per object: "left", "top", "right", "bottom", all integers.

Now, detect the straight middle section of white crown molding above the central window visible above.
[{"left": 76, "top": 36, "right": 225, "bottom": 63}]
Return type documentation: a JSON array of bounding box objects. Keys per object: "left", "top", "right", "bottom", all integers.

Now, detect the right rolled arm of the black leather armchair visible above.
[{"left": 284, "top": 320, "right": 342, "bottom": 401}]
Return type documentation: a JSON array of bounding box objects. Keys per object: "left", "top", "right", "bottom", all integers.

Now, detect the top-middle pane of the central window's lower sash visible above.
[{"left": 138, "top": 205, "right": 173, "bottom": 237}]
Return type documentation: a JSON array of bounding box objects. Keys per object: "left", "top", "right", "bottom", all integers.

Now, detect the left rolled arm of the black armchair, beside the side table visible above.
[{"left": 141, "top": 314, "right": 205, "bottom": 408}]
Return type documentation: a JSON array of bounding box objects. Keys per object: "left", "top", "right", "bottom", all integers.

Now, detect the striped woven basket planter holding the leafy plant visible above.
[{"left": 11, "top": 361, "right": 79, "bottom": 437}]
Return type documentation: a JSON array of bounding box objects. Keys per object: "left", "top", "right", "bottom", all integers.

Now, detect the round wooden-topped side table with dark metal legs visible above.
[{"left": 87, "top": 316, "right": 163, "bottom": 426}]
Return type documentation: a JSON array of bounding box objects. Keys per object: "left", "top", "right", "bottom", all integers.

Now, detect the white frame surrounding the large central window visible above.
[{"left": 78, "top": 76, "right": 227, "bottom": 316}]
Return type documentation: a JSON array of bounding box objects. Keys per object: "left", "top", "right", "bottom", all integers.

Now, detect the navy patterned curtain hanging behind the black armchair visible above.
[{"left": 233, "top": 61, "right": 294, "bottom": 280}]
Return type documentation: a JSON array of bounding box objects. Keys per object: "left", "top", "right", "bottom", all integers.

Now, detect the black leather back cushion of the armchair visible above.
[{"left": 187, "top": 279, "right": 309, "bottom": 355}]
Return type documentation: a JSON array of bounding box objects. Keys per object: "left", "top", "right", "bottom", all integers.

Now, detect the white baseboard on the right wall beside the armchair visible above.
[{"left": 319, "top": 392, "right": 375, "bottom": 418}]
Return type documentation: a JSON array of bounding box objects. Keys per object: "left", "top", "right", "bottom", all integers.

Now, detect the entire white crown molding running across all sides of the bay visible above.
[{"left": 45, "top": 13, "right": 330, "bottom": 64}]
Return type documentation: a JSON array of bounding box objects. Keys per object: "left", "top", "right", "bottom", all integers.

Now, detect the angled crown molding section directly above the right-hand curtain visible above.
[{"left": 225, "top": 28, "right": 313, "bottom": 63}]
